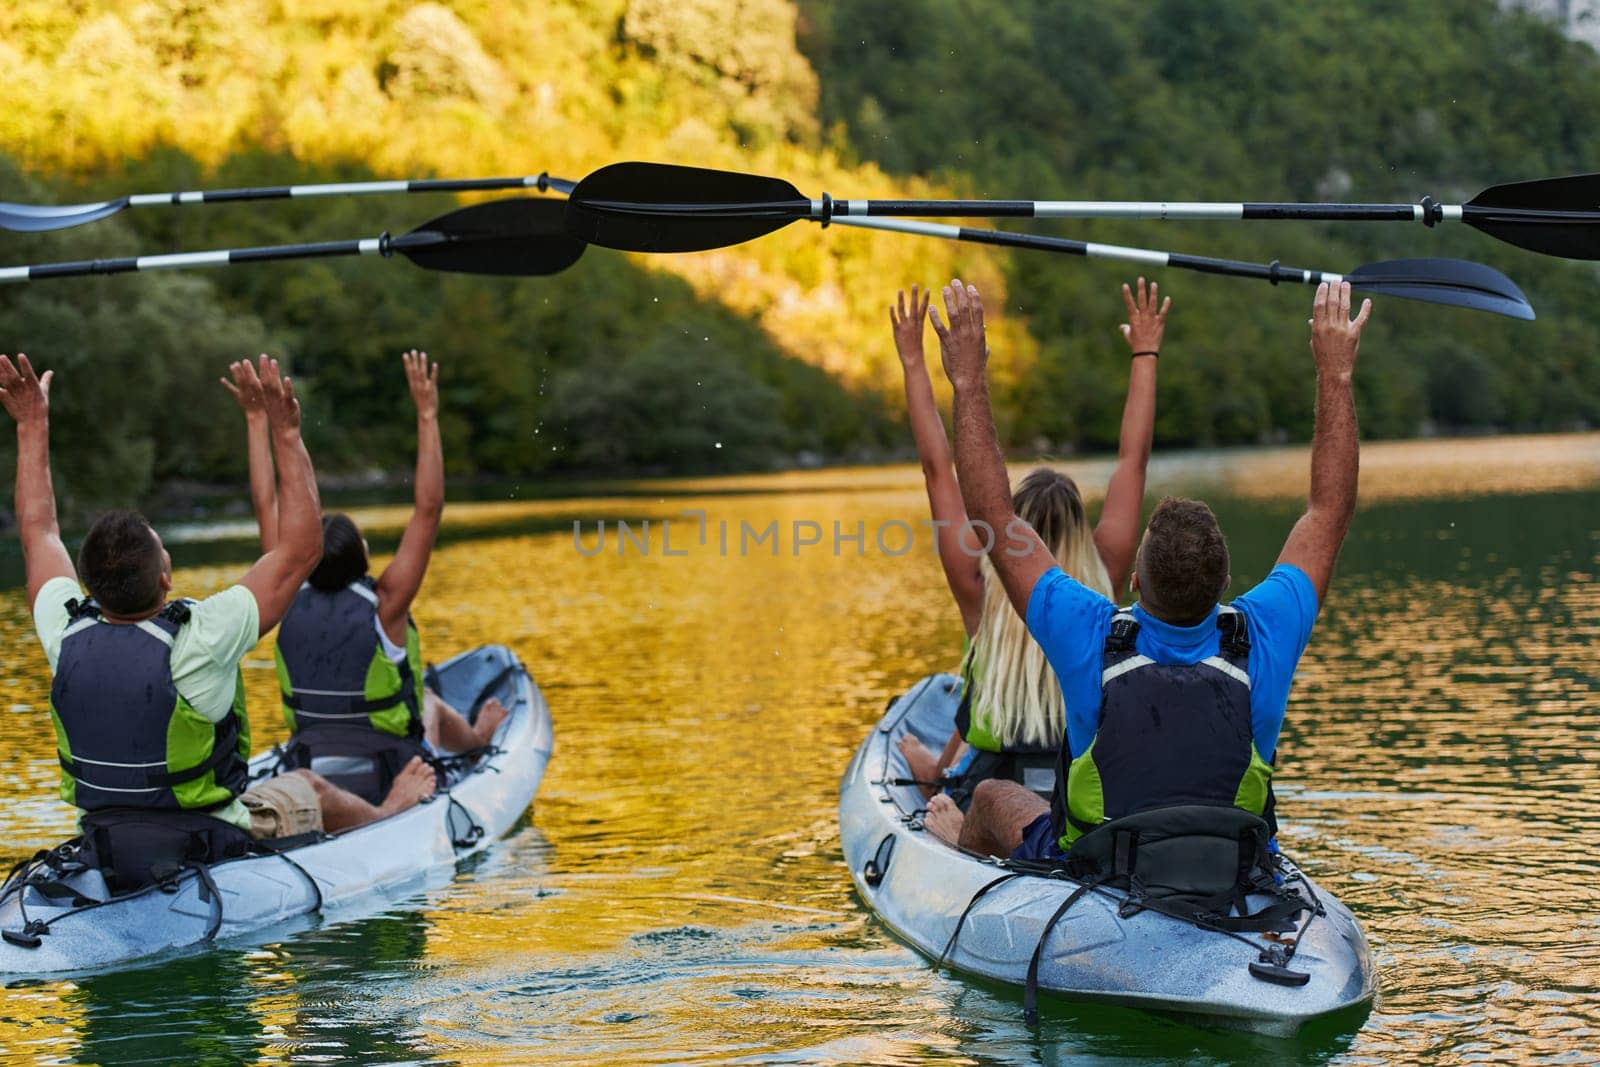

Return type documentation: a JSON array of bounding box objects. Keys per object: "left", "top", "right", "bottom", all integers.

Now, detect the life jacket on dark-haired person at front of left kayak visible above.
[{"left": 275, "top": 577, "right": 427, "bottom": 805}]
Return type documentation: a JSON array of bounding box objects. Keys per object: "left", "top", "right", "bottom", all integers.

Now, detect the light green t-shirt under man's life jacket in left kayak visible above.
[{"left": 34, "top": 577, "right": 261, "bottom": 830}]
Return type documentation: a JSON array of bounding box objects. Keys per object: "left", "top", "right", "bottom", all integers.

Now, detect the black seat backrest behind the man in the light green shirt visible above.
[{"left": 82, "top": 808, "right": 251, "bottom": 894}]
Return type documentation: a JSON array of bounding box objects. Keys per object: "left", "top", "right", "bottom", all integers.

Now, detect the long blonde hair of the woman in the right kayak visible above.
[{"left": 962, "top": 467, "right": 1115, "bottom": 749}]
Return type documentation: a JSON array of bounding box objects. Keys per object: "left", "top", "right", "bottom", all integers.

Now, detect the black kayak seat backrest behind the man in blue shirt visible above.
[{"left": 1067, "top": 805, "right": 1267, "bottom": 899}]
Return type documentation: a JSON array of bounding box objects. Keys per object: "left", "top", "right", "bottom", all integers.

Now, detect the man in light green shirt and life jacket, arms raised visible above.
[{"left": 0, "top": 355, "right": 435, "bottom": 837}]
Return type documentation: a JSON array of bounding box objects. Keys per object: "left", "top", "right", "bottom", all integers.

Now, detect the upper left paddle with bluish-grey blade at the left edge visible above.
[{"left": 0, "top": 174, "right": 573, "bottom": 234}]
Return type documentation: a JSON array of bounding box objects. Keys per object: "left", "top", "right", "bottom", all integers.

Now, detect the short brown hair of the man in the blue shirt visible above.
[{"left": 1134, "top": 496, "right": 1229, "bottom": 625}]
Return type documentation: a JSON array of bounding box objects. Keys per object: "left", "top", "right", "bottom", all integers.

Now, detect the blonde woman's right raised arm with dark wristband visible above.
[{"left": 1094, "top": 278, "right": 1173, "bottom": 590}]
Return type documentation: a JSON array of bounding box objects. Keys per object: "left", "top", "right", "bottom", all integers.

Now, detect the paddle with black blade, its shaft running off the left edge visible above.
[{"left": 0, "top": 198, "right": 586, "bottom": 283}]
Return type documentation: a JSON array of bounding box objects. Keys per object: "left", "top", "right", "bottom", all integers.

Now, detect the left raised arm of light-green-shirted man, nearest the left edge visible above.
[{"left": 0, "top": 354, "right": 78, "bottom": 609}]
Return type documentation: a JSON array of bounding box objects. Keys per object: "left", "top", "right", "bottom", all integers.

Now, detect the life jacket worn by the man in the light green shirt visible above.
[{"left": 50, "top": 600, "right": 250, "bottom": 811}]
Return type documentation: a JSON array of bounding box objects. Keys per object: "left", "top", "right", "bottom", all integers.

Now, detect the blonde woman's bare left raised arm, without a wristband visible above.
[{"left": 890, "top": 285, "right": 984, "bottom": 637}]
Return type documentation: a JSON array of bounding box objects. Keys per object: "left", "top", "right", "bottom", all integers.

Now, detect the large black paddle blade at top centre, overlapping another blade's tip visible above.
[{"left": 566, "top": 163, "right": 811, "bottom": 251}]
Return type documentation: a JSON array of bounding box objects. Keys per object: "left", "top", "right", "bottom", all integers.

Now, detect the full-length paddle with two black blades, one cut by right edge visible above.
[{"left": 566, "top": 163, "right": 1600, "bottom": 259}]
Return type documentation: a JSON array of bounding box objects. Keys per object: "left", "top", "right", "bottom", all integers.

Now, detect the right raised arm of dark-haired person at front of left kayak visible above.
[{"left": 378, "top": 349, "right": 445, "bottom": 645}]
